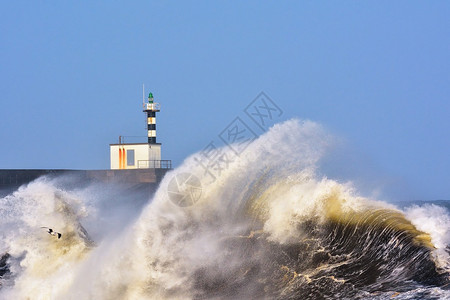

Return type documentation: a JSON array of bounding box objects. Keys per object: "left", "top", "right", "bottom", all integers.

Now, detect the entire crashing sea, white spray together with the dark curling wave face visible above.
[{"left": 0, "top": 120, "right": 450, "bottom": 299}]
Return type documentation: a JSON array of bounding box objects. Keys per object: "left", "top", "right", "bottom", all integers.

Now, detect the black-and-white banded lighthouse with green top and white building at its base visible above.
[{"left": 109, "top": 89, "right": 172, "bottom": 170}]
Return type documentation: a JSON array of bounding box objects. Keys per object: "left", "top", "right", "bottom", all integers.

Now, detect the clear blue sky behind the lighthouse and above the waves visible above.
[{"left": 0, "top": 1, "right": 450, "bottom": 199}]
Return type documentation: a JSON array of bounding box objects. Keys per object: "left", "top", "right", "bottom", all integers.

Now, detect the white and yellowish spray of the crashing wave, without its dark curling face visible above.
[{"left": 0, "top": 120, "right": 448, "bottom": 299}]
